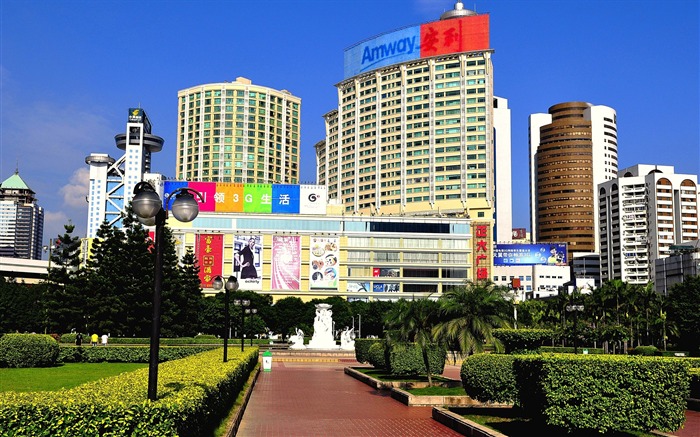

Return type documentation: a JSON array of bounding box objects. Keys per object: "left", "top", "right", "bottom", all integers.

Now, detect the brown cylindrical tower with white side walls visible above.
[{"left": 529, "top": 102, "right": 617, "bottom": 256}]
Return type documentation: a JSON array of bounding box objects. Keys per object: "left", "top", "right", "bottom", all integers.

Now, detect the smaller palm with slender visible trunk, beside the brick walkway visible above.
[{"left": 384, "top": 299, "right": 439, "bottom": 386}]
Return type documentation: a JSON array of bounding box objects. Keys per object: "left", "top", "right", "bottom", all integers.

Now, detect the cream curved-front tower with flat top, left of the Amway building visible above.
[{"left": 176, "top": 77, "right": 301, "bottom": 184}]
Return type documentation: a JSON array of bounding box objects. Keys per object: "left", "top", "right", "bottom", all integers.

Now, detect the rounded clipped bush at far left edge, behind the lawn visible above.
[{"left": 0, "top": 334, "right": 59, "bottom": 367}]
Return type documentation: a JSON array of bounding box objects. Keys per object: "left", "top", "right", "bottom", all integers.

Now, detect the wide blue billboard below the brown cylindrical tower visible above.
[{"left": 493, "top": 243, "right": 568, "bottom": 266}]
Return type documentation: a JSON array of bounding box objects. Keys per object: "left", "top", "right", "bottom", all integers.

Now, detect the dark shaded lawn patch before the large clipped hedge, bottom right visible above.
[{"left": 462, "top": 408, "right": 655, "bottom": 437}]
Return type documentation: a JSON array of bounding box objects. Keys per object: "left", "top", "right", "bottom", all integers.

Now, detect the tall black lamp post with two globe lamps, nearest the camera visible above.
[{"left": 131, "top": 182, "right": 204, "bottom": 401}]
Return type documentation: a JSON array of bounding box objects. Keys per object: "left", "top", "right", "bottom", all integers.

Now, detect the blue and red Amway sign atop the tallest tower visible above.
[{"left": 343, "top": 15, "right": 489, "bottom": 79}]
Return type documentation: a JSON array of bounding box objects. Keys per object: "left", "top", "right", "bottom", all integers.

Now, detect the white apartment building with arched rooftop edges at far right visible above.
[{"left": 597, "top": 165, "right": 700, "bottom": 284}]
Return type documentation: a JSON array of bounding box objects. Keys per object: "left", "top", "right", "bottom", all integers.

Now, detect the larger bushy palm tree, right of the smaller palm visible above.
[{"left": 433, "top": 281, "right": 512, "bottom": 354}]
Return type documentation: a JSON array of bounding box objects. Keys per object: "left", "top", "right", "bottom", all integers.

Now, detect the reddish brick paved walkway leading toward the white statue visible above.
[{"left": 236, "top": 361, "right": 461, "bottom": 437}]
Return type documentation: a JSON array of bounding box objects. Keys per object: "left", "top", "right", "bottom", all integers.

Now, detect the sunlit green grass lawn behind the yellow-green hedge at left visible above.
[{"left": 0, "top": 363, "right": 148, "bottom": 391}]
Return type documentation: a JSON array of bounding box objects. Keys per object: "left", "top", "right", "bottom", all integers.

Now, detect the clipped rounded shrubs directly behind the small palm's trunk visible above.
[{"left": 389, "top": 343, "right": 447, "bottom": 375}]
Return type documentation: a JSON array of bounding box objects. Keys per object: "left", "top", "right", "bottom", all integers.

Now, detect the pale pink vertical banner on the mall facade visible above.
[{"left": 272, "top": 235, "right": 301, "bottom": 290}]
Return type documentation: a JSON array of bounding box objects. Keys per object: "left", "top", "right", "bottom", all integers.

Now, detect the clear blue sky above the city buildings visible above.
[{"left": 0, "top": 0, "right": 700, "bottom": 241}]
